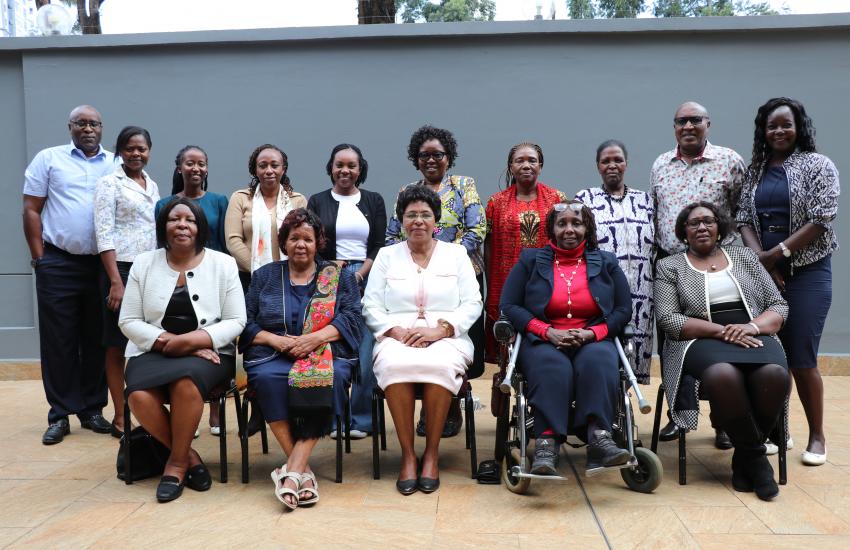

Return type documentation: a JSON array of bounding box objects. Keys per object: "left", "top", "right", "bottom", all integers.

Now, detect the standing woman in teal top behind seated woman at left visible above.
[{"left": 155, "top": 145, "right": 228, "bottom": 254}]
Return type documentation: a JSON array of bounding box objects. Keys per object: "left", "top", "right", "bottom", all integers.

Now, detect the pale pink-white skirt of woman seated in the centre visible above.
[{"left": 372, "top": 338, "right": 469, "bottom": 395}]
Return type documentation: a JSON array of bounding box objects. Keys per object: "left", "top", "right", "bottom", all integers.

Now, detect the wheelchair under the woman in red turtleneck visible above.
[{"left": 492, "top": 316, "right": 664, "bottom": 494}]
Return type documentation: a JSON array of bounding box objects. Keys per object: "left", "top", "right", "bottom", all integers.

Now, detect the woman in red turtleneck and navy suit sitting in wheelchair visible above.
[{"left": 500, "top": 200, "right": 632, "bottom": 475}]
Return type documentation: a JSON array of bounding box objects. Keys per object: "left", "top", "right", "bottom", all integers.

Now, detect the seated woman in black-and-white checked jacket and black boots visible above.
[{"left": 655, "top": 202, "right": 789, "bottom": 500}]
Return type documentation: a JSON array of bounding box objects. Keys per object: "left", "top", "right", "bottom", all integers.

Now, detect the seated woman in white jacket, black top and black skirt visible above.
[{"left": 118, "top": 197, "right": 245, "bottom": 502}]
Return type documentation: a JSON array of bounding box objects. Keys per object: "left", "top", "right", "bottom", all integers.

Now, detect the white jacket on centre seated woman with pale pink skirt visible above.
[{"left": 363, "top": 241, "right": 482, "bottom": 359}]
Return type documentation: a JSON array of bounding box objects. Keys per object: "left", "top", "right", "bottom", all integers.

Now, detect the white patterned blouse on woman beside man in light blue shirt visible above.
[{"left": 94, "top": 165, "right": 159, "bottom": 262}]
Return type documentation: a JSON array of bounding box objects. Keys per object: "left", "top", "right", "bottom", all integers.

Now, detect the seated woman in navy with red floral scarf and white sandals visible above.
[{"left": 239, "top": 208, "right": 363, "bottom": 510}]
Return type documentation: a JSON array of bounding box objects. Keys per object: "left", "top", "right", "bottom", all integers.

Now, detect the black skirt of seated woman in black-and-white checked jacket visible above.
[{"left": 682, "top": 302, "right": 788, "bottom": 378}]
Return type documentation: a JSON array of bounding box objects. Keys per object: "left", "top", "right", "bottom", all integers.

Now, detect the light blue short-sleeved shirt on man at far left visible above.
[{"left": 24, "top": 143, "right": 115, "bottom": 254}]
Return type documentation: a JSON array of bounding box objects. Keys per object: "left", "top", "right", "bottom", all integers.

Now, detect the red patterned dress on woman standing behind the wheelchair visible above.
[{"left": 484, "top": 182, "right": 567, "bottom": 361}]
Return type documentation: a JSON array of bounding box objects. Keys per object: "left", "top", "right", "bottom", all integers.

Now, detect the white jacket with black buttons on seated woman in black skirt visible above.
[{"left": 118, "top": 248, "right": 245, "bottom": 357}]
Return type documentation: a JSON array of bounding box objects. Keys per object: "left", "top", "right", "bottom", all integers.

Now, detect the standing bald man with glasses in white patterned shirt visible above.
[{"left": 649, "top": 101, "right": 745, "bottom": 449}]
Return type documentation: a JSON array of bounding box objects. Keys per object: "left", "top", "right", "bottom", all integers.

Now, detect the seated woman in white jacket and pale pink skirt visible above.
[{"left": 363, "top": 186, "right": 482, "bottom": 495}]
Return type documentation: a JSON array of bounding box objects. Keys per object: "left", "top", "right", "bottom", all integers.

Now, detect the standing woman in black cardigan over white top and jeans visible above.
[{"left": 307, "top": 143, "right": 387, "bottom": 439}]
